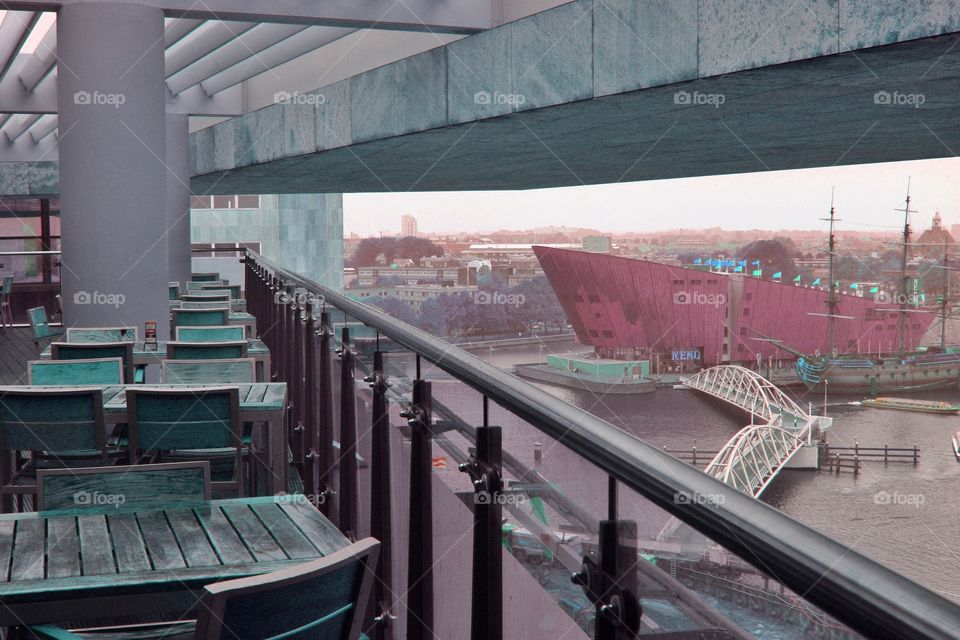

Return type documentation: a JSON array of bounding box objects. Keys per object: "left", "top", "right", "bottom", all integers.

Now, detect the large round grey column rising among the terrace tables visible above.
[{"left": 57, "top": 2, "right": 169, "bottom": 338}]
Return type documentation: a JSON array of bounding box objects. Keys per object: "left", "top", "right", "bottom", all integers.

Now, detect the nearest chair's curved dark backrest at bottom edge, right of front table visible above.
[{"left": 195, "top": 538, "right": 380, "bottom": 640}]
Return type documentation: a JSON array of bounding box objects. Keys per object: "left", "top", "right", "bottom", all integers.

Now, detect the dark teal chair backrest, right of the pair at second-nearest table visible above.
[{"left": 127, "top": 386, "right": 240, "bottom": 452}]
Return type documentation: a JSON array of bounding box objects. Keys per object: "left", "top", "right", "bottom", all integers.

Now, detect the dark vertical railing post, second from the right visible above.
[{"left": 460, "top": 426, "right": 503, "bottom": 640}]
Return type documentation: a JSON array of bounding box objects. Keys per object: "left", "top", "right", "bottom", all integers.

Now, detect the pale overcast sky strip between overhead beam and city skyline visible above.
[{"left": 343, "top": 158, "right": 960, "bottom": 236}]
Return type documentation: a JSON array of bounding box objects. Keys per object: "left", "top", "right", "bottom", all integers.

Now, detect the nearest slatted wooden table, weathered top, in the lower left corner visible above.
[{"left": 0, "top": 495, "right": 349, "bottom": 627}]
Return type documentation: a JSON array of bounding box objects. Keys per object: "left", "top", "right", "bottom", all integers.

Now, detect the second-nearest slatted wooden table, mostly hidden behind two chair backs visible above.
[{"left": 0, "top": 382, "right": 288, "bottom": 494}]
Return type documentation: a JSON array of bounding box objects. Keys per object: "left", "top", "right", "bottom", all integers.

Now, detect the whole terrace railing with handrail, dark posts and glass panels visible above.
[{"left": 245, "top": 251, "right": 960, "bottom": 640}]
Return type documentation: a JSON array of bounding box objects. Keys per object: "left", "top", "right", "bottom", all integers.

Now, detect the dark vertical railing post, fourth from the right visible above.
[{"left": 364, "top": 350, "right": 393, "bottom": 640}]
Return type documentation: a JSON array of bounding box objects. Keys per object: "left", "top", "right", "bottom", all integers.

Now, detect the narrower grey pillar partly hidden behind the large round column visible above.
[{"left": 167, "top": 113, "right": 191, "bottom": 287}]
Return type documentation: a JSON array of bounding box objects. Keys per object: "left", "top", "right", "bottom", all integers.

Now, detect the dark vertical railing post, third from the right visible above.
[{"left": 400, "top": 377, "right": 434, "bottom": 640}]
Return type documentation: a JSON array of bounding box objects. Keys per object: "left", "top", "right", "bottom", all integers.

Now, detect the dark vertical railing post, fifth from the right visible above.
[{"left": 337, "top": 327, "right": 359, "bottom": 540}]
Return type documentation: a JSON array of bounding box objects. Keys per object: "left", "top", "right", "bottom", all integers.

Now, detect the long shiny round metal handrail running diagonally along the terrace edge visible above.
[{"left": 246, "top": 249, "right": 960, "bottom": 638}]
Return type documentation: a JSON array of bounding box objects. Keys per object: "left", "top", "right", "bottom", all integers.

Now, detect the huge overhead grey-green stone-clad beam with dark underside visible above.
[{"left": 0, "top": 0, "right": 960, "bottom": 194}]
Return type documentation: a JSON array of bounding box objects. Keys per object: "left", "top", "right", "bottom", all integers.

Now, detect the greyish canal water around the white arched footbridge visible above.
[{"left": 476, "top": 342, "right": 960, "bottom": 602}]
